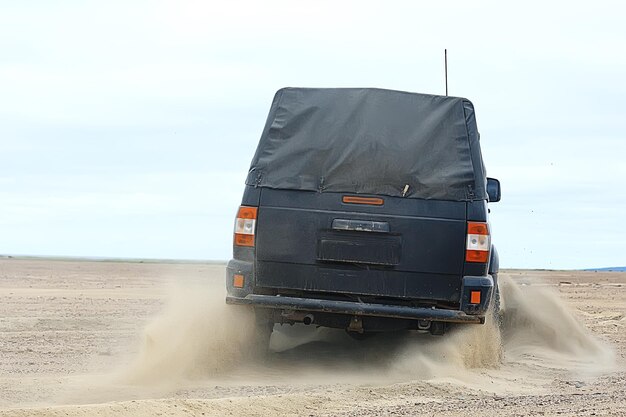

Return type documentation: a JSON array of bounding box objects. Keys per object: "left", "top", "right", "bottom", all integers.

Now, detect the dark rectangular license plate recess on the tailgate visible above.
[{"left": 317, "top": 230, "right": 402, "bottom": 266}]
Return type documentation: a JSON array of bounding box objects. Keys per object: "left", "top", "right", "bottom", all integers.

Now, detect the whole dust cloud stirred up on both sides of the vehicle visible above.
[{"left": 123, "top": 277, "right": 613, "bottom": 385}]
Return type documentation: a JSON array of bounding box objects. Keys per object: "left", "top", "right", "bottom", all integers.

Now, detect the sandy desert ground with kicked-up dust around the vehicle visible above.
[{"left": 0, "top": 259, "right": 626, "bottom": 416}]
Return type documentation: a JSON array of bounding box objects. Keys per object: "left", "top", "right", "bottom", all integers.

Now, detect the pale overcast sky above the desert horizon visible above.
[{"left": 0, "top": 1, "right": 626, "bottom": 268}]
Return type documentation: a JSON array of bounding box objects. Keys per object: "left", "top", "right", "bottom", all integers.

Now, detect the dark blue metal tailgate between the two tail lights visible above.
[{"left": 256, "top": 189, "right": 466, "bottom": 300}]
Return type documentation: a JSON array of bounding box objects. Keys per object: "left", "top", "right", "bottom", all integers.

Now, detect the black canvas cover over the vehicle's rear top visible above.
[{"left": 246, "top": 88, "right": 487, "bottom": 201}]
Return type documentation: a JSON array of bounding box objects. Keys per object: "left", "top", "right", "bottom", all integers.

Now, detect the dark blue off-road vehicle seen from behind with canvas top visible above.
[{"left": 226, "top": 89, "right": 497, "bottom": 335}]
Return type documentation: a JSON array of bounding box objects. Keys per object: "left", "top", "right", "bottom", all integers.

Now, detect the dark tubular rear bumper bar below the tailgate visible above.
[{"left": 226, "top": 294, "right": 484, "bottom": 323}]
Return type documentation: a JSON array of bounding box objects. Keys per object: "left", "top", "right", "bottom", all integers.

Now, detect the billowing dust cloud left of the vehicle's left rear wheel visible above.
[{"left": 120, "top": 285, "right": 254, "bottom": 384}]
